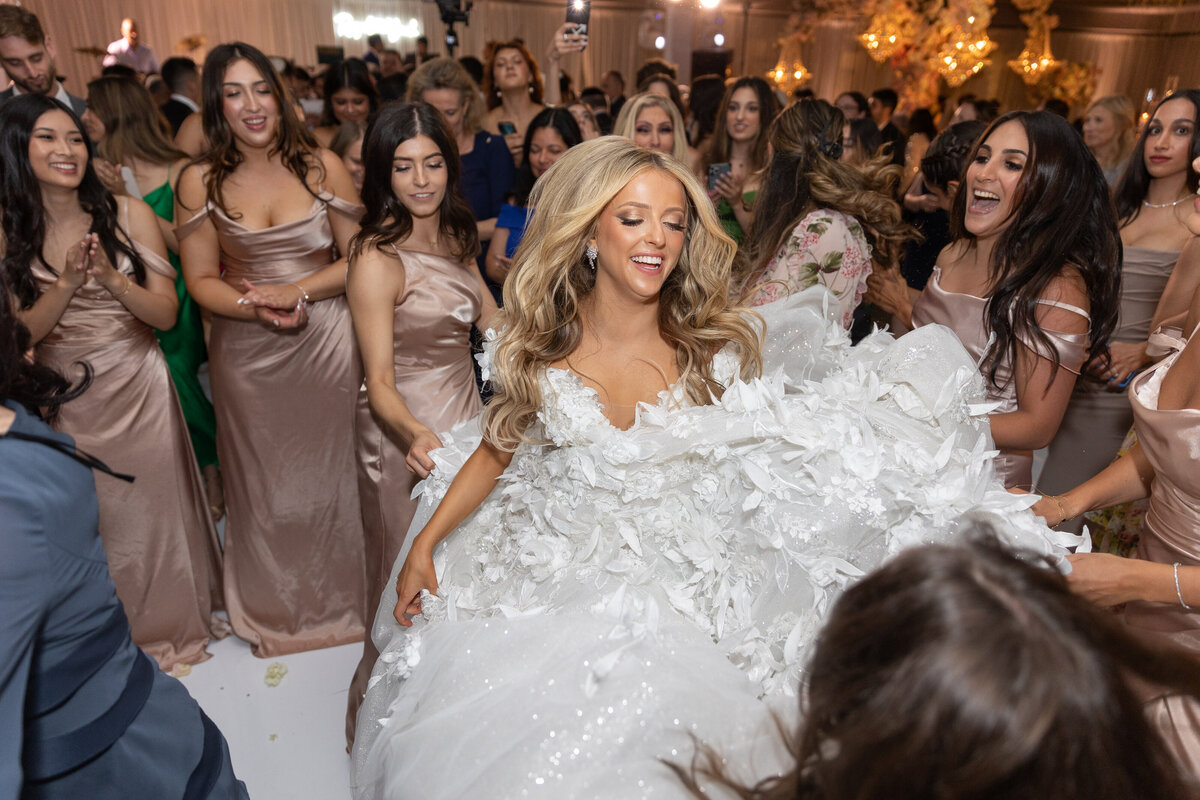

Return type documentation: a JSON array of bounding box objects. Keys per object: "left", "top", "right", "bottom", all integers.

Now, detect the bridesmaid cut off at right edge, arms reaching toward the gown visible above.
[{"left": 1033, "top": 260, "right": 1200, "bottom": 777}]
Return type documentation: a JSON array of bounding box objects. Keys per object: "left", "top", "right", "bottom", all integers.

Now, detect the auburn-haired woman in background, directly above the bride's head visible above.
[{"left": 484, "top": 40, "right": 545, "bottom": 166}]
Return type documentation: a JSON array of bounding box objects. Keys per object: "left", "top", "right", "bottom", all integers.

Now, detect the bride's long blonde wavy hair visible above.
[{"left": 484, "top": 136, "right": 762, "bottom": 451}]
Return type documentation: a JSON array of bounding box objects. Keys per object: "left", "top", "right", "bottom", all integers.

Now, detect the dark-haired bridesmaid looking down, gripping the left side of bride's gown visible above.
[{"left": 346, "top": 103, "right": 496, "bottom": 740}]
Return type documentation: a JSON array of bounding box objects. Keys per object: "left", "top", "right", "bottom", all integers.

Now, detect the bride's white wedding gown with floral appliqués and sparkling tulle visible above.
[{"left": 352, "top": 288, "right": 1078, "bottom": 800}]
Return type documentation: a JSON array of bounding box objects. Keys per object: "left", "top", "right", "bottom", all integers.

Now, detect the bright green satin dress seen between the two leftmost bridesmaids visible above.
[{"left": 142, "top": 173, "right": 217, "bottom": 469}]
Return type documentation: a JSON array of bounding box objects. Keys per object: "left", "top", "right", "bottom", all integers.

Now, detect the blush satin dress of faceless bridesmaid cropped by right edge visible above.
[{"left": 1124, "top": 332, "right": 1200, "bottom": 777}]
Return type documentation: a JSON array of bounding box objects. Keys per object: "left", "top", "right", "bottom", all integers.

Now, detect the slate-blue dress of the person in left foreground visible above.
[{"left": 0, "top": 402, "right": 247, "bottom": 800}]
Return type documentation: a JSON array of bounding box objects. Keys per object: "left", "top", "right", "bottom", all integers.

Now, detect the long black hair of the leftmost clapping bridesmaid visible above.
[{"left": 0, "top": 94, "right": 146, "bottom": 308}]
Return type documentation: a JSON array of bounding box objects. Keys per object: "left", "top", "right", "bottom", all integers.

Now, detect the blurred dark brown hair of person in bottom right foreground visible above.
[{"left": 672, "top": 523, "right": 1200, "bottom": 800}]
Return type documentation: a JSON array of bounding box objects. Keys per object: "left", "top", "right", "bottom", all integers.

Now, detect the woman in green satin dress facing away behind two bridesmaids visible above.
[{"left": 83, "top": 76, "right": 224, "bottom": 521}]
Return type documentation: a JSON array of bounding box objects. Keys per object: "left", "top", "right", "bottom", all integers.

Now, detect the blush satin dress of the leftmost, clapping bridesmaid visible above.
[{"left": 34, "top": 239, "right": 229, "bottom": 670}]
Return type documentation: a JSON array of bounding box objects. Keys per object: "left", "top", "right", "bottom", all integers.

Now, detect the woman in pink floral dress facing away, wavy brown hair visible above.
[{"left": 733, "top": 100, "right": 907, "bottom": 327}]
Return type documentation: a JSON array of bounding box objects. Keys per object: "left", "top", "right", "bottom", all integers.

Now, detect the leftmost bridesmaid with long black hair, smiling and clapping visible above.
[{"left": 0, "top": 94, "right": 227, "bottom": 669}]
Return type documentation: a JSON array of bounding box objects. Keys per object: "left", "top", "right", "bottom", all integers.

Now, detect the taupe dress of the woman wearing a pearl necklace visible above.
[{"left": 1038, "top": 247, "right": 1180, "bottom": 513}]
